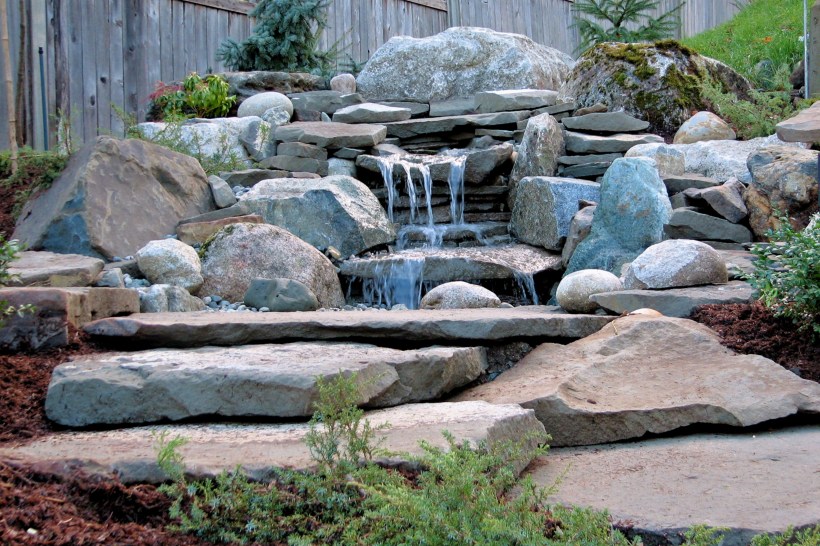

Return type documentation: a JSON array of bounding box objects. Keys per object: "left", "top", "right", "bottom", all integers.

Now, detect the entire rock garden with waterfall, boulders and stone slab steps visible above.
[{"left": 0, "top": 2, "right": 820, "bottom": 544}]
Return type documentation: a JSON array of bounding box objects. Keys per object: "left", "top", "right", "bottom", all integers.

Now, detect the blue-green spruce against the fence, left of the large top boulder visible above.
[{"left": 216, "top": 0, "right": 336, "bottom": 73}]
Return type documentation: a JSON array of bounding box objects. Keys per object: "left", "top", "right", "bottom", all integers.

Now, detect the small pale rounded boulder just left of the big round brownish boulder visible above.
[{"left": 136, "top": 239, "right": 202, "bottom": 292}]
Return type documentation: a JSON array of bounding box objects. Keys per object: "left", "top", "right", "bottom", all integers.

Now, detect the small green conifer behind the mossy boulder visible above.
[{"left": 573, "top": 0, "right": 684, "bottom": 51}]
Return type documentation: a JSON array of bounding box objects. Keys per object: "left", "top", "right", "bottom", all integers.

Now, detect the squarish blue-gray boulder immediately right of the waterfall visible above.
[{"left": 510, "top": 176, "right": 601, "bottom": 250}]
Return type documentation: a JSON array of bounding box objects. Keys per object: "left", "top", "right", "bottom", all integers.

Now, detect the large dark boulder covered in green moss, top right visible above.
[{"left": 559, "top": 40, "right": 751, "bottom": 135}]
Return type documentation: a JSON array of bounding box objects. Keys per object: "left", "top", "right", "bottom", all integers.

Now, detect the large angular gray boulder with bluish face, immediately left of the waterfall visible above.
[{"left": 240, "top": 176, "right": 396, "bottom": 256}]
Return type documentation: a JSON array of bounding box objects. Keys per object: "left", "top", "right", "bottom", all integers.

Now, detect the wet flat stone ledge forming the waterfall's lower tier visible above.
[{"left": 340, "top": 245, "right": 562, "bottom": 282}]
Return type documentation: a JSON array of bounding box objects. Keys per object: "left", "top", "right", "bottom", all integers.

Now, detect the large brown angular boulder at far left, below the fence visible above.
[{"left": 13, "top": 137, "right": 214, "bottom": 259}]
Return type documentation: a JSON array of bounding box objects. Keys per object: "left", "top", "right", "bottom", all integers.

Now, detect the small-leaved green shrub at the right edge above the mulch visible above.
[{"left": 748, "top": 213, "right": 820, "bottom": 338}]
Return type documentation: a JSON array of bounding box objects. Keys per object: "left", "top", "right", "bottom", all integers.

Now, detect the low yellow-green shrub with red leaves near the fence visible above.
[{"left": 148, "top": 72, "right": 236, "bottom": 119}]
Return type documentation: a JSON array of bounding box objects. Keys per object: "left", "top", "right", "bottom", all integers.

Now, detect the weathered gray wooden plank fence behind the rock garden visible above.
[{"left": 0, "top": 0, "right": 737, "bottom": 149}]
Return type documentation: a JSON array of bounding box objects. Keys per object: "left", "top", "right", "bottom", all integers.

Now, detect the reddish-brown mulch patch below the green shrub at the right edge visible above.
[{"left": 692, "top": 302, "right": 820, "bottom": 382}]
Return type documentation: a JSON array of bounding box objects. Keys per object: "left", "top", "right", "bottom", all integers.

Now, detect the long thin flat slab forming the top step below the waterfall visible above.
[{"left": 84, "top": 305, "right": 614, "bottom": 347}]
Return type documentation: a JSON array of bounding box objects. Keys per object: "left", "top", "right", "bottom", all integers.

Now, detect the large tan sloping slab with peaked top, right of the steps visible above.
[{"left": 453, "top": 315, "right": 820, "bottom": 446}]
